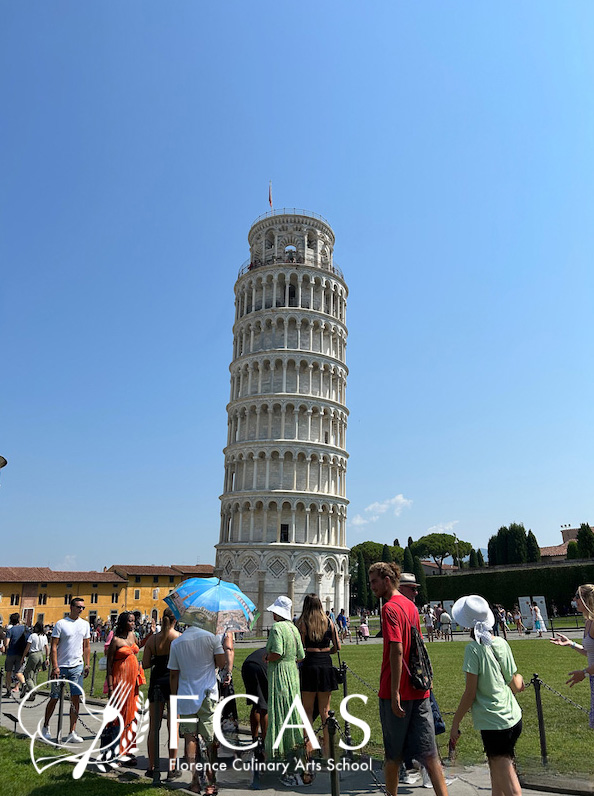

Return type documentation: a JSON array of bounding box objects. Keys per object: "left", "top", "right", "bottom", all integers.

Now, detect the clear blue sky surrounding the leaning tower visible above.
[{"left": 0, "top": 0, "right": 594, "bottom": 569}]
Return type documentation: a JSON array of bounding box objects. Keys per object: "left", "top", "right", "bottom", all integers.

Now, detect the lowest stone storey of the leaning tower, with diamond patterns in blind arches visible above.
[{"left": 215, "top": 543, "right": 350, "bottom": 629}]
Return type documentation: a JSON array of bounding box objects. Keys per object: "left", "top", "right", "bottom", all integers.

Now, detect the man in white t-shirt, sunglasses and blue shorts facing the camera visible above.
[{"left": 41, "top": 597, "right": 91, "bottom": 743}]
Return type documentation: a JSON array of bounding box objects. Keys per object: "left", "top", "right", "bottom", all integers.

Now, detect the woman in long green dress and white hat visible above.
[{"left": 265, "top": 596, "right": 311, "bottom": 785}]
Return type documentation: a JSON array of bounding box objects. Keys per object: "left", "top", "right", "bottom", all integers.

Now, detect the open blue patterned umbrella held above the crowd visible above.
[{"left": 165, "top": 578, "right": 259, "bottom": 635}]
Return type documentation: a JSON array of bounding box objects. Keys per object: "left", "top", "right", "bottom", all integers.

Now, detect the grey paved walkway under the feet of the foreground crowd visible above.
[{"left": 1, "top": 698, "right": 594, "bottom": 796}]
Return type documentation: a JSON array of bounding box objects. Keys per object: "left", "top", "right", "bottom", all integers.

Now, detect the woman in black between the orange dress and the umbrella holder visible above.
[{"left": 142, "top": 608, "right": 181, "bottom": 780}]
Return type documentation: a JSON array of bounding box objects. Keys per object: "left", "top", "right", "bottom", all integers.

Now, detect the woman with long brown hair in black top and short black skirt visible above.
[{"left": 297, "top": 594, "right": 340, "bottom": 757}]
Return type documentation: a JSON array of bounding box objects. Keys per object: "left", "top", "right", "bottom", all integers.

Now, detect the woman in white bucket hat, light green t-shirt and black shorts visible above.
[{"left": 450, "top": 594, "right": 524, "bottom": 796}]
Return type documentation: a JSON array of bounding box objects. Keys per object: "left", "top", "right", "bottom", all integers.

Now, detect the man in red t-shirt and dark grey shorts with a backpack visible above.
[{"left": 369, "top": 561, "right": 448, "bottom": 796}]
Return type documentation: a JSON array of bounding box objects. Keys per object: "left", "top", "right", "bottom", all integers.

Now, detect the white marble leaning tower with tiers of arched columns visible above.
[{"left": 216, "top": 210, "right": 349, "bottom": 624}]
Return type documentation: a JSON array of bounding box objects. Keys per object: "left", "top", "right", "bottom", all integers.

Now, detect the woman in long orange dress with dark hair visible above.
[{"left": 107, "top": 611, "right": 146, "bottom": 767}]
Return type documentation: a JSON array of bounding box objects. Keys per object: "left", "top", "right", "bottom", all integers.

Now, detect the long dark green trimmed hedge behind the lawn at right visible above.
[{"left": 427, "top": 563, "right": 594, "bottom": 609}]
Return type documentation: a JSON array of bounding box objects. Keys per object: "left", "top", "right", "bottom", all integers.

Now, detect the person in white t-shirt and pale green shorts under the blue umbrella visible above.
[{"left": 167, "top": 627, "right": 225, "bottom": 786}]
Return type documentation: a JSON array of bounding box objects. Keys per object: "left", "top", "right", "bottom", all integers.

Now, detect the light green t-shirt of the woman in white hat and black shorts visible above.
[{"left": 462, "top": 636, "right": 522, "bottom": 730}]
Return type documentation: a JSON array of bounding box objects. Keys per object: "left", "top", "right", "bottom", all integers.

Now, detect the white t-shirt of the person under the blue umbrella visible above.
[{"left": 167, "top": 627, "right": 223, "bottom": 716}]
